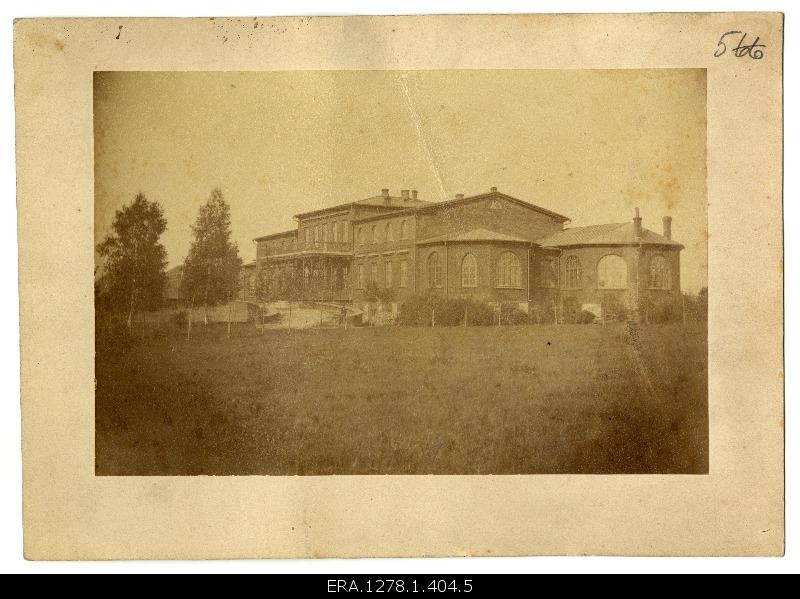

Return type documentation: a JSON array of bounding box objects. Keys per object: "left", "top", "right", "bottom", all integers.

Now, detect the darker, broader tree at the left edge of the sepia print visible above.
[{"left": 97, "top": 193, "right": 167, "bottom": 329}]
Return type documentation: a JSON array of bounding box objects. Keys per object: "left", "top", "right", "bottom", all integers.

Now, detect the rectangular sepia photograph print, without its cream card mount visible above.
[{"left": 93, "top": 70, "right": 709, "bottom": 476}]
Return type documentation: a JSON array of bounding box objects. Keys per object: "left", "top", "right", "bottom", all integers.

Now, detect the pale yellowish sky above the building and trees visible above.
[{"left": 94, "top": 69, "right": 707, "bottom": 292}]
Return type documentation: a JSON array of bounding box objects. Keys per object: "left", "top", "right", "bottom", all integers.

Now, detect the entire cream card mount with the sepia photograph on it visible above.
[{"left": 15, "top": 13, "right": 783, "bottom": 559}]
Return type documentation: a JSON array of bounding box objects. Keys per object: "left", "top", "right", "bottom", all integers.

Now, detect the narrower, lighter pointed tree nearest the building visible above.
[{"left": 182, "top": 189, "right": 242, "bottom": 324}]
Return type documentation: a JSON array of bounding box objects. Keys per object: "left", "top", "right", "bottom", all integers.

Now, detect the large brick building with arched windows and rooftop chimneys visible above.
[{"left": 244, "top": 187, "right": 683, "bottom": 318}]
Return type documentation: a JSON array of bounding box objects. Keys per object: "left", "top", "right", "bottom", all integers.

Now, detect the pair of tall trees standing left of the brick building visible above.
[{"left": 95, "top": 189, "right": 242, "bottom": 330}]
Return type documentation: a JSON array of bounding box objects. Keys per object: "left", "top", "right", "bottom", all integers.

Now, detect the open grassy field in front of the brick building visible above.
[{"left": 95, "top": 324, "right": 708, "bottom": 475}]
